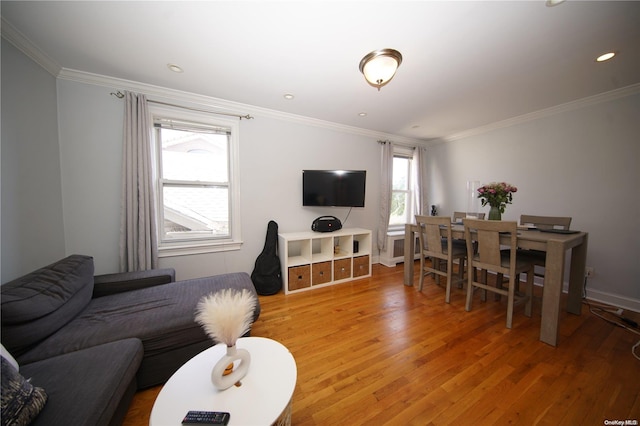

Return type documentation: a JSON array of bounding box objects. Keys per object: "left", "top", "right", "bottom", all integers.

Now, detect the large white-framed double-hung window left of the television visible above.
[{"left": 150, "top": 104, "right": 240, "bottom": 256}]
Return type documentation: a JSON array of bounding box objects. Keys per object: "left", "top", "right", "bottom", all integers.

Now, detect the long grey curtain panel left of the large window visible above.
[{"left": 120, "top": 92, "right": 158, "bottom": 272}]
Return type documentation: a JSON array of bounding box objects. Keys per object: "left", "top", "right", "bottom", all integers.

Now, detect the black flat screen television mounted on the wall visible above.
[{"left": 302, "top": 170, "right": 367, "bottom": 207}]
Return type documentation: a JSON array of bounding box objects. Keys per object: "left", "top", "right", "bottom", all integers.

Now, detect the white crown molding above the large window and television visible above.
[{"left": 58, "top": 68, "right": 425, "bottom": 145}]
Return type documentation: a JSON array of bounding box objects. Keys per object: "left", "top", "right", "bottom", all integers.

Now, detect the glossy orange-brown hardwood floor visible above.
[{"left": 124, "top": 265, "right": 640, "bottom": 426}]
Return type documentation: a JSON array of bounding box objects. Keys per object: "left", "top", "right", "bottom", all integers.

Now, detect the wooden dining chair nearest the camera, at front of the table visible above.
[{"left": 464, "top": 219, "right": 533, "bottom": 328}]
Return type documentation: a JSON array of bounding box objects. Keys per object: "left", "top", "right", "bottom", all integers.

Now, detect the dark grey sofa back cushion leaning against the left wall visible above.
[{"left": 0, "top": 255, "right": 93, "bottom": 358}]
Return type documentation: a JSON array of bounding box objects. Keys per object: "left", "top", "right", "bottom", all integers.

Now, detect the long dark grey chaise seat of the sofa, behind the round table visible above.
[{"left": 17, "top": 272, "right": 260, "bottom": 387}]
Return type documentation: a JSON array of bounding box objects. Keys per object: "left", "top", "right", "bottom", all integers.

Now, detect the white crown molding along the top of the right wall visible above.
[{"left": 442, "top": 83, "right": 640, "bottom": 142}]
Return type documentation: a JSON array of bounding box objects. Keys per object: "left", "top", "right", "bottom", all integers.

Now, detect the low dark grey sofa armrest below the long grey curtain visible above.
[{"left": 93, "top": 268, "right": 176, "bottom": 298}]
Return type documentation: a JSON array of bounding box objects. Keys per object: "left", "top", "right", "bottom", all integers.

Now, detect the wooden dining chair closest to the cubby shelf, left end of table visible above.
[{"left": 416, "top": 215, "right": 467, "bottom": 303}]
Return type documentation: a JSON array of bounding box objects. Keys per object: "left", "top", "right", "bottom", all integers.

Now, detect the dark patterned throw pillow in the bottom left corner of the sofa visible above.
[{"left": 0, "top": 357, "right": 47, "bottom": 426}]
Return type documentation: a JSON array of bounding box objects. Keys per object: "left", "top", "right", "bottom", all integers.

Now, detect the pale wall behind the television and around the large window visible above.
[{"left": 58, "top": 80, "right": 380, "bottom": 279}]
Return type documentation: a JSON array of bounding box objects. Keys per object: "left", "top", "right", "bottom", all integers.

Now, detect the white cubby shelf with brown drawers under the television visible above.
[{"left": 278, "top": 228, "right": 372, "bottom": 294}]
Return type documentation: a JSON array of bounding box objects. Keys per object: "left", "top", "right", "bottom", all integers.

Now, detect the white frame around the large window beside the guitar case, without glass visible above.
[{"left": 149, "top": 103, "right": 242, "bottom": 257}]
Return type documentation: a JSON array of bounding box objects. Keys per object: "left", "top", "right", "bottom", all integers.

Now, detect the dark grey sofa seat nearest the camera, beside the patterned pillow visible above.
[{"left": 20, "top": 339, "right": 143, "bottom": 426}]
